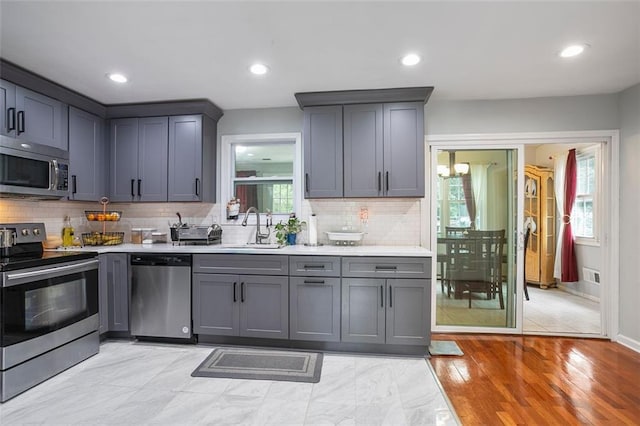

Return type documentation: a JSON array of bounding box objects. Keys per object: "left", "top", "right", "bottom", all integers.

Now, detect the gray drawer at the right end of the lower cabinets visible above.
[{"left": 342, "top": 257, "right": 431, "bottom": 278}]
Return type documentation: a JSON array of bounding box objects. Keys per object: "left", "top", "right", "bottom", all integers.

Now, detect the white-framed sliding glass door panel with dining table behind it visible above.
[{"left": 431, "top": 145, "right": 523, "bottom": 333}]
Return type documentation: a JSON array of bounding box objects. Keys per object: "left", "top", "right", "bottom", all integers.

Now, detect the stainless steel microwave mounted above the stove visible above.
[{"left": 0, "top": 136, "right": 69, "bottom": 199}]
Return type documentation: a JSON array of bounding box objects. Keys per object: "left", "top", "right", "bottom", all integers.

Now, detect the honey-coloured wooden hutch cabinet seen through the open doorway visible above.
[{"left": 524, "top": 165, "right": 556, "bottom": 288}]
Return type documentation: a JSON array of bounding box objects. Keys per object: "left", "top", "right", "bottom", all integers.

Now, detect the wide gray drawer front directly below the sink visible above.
[{"left": 193, "top": 254, "right": 289, "bottom": 275}]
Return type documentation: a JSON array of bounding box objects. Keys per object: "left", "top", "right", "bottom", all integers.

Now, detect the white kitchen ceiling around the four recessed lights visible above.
[{"left": 0, "top": 0, "right": 640, "bottom": 110}]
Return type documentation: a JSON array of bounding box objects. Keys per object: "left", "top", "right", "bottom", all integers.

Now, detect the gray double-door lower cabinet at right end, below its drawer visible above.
[{"left": 342, "top": 278, "right": 431, "bottom": 345}]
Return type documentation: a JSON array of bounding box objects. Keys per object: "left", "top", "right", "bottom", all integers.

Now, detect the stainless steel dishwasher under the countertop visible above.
[{"left": 130, "top": 254, "right": 192, "bottom": 339}]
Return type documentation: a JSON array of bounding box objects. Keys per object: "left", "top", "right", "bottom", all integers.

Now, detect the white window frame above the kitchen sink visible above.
[{"left": 219, "top": 132, "right": 303, "bottom": 225}]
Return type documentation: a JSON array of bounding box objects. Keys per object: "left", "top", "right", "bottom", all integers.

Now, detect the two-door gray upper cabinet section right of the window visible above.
[{"left": 344, "top": 102, "right": 425, "bottom": 197}]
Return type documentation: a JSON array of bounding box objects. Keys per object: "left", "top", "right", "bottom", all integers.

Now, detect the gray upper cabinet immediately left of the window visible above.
[{"left": 168, "top": 115, "right": 216, "bottom": 202}]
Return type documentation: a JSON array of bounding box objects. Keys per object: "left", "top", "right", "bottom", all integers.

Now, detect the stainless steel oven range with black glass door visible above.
[{"left": 0, "top": 223, "right": 99, "bottom": 402}]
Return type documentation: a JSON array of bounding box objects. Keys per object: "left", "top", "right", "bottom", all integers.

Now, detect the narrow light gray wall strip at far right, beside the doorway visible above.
[{"left": 619, "top": 84, "right": 640, "bottom": 350}]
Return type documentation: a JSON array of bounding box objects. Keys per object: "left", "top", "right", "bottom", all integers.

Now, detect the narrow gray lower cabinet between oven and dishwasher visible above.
[{"left": 98, "top": 253, "right": 129, "bottom": 334}]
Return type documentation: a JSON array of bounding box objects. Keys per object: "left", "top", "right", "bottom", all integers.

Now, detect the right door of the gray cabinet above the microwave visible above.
[{"left": 16, "top": 86, "right": 68, "bottom": 151}]
